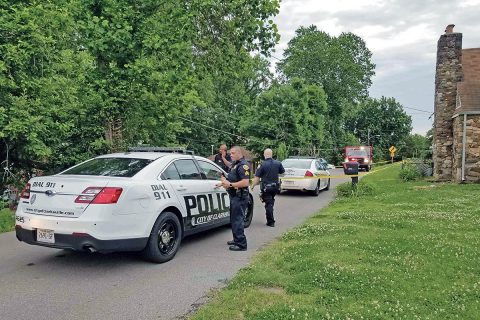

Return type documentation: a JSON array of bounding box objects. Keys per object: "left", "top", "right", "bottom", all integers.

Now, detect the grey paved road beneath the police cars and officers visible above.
[{"left": 0, "top": 170, "right": 345, "bottom": 320}]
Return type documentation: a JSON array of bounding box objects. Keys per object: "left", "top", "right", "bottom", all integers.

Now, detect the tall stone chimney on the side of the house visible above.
[{"left": 433, "top": 24, "right": 462, "bottom": 180}]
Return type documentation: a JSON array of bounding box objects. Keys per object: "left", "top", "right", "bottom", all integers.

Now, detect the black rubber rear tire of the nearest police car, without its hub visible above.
[{"left": 143, "top": 211, "right": 182, "bottom": 263}]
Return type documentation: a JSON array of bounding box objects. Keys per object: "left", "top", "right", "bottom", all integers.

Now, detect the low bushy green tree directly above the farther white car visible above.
[{"left": 241, "top": 79, "right": 327, "bottom": 155}]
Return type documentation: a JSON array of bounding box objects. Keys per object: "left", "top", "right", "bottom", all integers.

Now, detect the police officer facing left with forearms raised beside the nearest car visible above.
[{"left": 217, "top": 146, "right": 250, "bottom": 251}]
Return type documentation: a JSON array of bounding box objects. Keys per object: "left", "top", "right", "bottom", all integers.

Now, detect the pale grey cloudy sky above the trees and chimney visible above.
[{"left": 272, "top": 0, "right": 480, "bottom": 134}]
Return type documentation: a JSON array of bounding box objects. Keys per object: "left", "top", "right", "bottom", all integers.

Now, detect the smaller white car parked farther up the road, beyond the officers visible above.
[{"left": 280, "top": 157, "right": 330, "bottom": 196}]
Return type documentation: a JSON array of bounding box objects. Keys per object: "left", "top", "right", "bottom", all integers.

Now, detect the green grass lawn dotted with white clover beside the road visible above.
[{"left": 191, "top": 165, "right": 480, "bottom": 320}]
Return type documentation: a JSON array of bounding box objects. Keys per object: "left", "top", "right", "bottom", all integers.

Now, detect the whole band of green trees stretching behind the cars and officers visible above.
[{"left": 0, "top": 0, "right": 420, "bottom": 185}]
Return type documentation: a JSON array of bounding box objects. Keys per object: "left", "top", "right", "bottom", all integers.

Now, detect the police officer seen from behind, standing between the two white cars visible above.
[{"left": 252, "top": 149, "right": 285, "bottom": 227}]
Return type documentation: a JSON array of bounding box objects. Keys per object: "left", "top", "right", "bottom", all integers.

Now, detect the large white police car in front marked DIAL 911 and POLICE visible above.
[{"left": 15, "top": 148, "right": 253, "bottom": 263}]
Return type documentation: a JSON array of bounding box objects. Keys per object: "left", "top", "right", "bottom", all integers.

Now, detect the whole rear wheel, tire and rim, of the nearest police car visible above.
[{"left": 143, "top": 212, "right": 182, "bottom": 263}]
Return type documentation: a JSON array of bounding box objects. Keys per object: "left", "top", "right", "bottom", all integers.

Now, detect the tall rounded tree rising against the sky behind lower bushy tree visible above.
[{"left": 277, "top": 26, "right": 375, "bottom": 156}]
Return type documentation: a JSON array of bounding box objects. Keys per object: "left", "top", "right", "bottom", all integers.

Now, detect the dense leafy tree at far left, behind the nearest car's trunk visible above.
[{"left": 0, "top": 1, "right": 102, "bottom": 174}]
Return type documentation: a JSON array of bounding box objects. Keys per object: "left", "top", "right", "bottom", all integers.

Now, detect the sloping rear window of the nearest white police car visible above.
[{"left": 61, "top": 158, "right": 154, "bottom": 178}]
